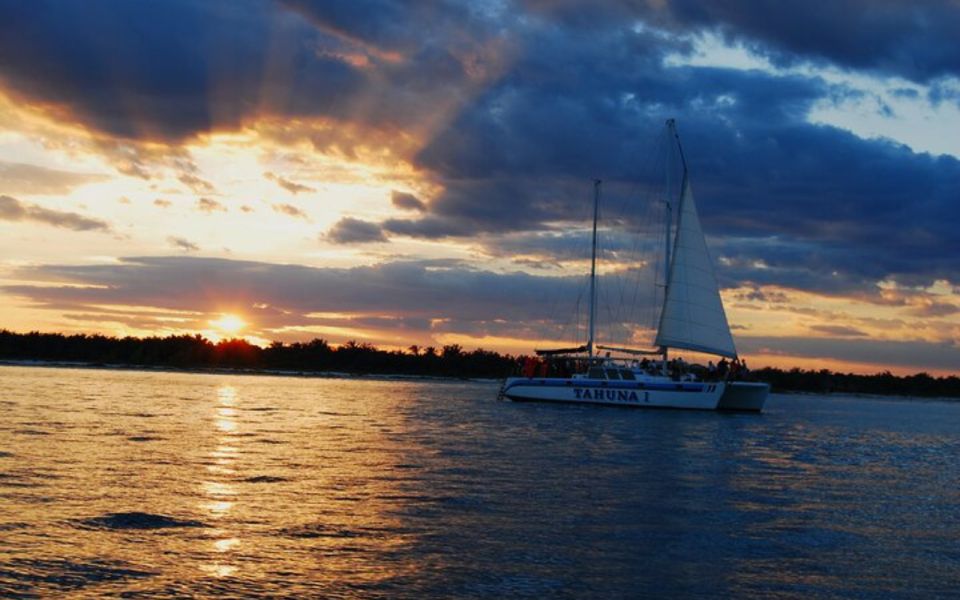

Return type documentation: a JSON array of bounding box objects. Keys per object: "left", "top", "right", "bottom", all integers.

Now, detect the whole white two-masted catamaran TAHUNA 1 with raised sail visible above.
[{"left": 500, "top": 119, "right": 770, "bottom": 412}]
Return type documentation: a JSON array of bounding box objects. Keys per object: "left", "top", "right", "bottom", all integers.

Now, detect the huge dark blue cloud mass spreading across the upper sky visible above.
[{"left": 0, "top": 0, "right": 960, "bottom": 311}]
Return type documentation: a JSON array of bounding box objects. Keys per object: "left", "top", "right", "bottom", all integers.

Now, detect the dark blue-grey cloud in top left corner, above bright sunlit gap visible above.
[{"left": 0, "top": 0, "right": 496, "bottom": 142}]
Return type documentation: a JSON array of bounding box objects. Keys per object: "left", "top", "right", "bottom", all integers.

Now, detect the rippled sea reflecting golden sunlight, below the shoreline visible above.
[{"left": 0, "top": 367, "right": 960, "bottom": 598}]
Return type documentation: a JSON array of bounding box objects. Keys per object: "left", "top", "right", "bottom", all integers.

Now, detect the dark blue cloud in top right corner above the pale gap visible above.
[{"left": 521, "top": 0, "right": 960, "bottom": 81}]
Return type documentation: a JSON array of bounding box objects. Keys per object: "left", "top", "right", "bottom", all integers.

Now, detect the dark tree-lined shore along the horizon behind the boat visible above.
[{"left": 0, "top": 329, "right": 960, "bottom": 398}]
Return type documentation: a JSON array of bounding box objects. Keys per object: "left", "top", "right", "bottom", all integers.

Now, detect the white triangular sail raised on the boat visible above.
[{"left": 655, "top": 182, "right": 737, "bottom": 358}]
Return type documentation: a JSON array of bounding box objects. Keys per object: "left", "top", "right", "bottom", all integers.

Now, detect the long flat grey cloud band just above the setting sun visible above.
[{"left": 3, "top": 256, "right": 584, "bottom": 327}]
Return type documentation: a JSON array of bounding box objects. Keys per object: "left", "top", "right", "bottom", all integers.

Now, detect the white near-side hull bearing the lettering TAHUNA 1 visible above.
[{"left": 501, "top": 377, "right": 728, "bottom": 410}]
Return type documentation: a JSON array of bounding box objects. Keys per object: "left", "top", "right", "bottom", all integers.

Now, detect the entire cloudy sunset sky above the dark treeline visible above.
[{"left": 0, "top": 0, "right": 960, "bottom": 374}]
